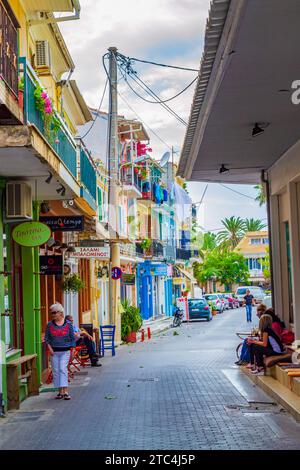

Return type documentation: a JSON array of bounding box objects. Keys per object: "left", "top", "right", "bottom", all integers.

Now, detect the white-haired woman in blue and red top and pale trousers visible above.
[{"left": 45, "top": 303, "right": 76, "bottom": 400}]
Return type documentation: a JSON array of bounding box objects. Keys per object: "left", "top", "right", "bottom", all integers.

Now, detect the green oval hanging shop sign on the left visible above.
[{"left": 12, "top": 222, "right": 51, "bottom": 247}]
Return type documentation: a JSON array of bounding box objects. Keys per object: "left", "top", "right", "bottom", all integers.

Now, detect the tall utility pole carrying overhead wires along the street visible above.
[{"left": 108, "top": 47, "right": 121, "bottom": 342}]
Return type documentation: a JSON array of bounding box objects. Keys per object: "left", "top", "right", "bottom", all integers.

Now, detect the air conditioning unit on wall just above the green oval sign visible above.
[{"left": 6, "top": 181, "right": 32, "bottom": 219}]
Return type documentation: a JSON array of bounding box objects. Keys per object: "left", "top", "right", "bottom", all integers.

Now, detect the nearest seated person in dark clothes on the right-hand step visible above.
[{"left": 247, "top": 314, "right": 284, "bottom": 375}]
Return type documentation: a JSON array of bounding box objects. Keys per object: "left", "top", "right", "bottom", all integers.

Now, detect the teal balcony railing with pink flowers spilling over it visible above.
[{"left": 19, "top": 57, "right": 77, "bottom": 178}]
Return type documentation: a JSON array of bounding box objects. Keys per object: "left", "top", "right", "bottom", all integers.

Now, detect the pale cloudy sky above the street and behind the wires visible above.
[{"left": 60, "top": 0, "right": 266, "bottom": 230}]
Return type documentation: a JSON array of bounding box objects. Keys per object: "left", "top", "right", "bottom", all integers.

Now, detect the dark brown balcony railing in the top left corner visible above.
[{"left": 0, "top": 3, "right": 18, "bottom": 96}]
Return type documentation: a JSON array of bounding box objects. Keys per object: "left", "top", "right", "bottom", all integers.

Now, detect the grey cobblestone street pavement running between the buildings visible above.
[{"left": 0, "top": 309, "right": 300, "bottom": 450}]
